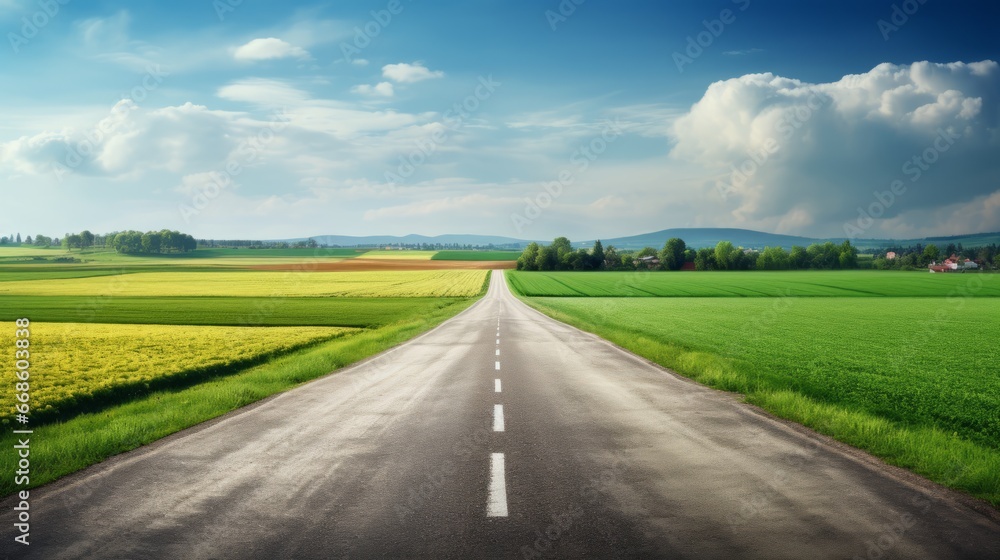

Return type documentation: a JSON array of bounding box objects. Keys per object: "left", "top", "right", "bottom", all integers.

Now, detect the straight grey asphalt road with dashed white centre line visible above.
[{"left": 3, "top": 273, "right": 1000, "bottom": 560}]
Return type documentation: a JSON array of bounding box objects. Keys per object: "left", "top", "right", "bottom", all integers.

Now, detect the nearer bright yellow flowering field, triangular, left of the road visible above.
[{"left": 0, "top": 323, "right": 361, "bottom": 420}]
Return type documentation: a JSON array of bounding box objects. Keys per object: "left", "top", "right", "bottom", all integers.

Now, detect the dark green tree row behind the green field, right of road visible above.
[{"left": 517, "top": 237, "right": 859, "bottom": 271}]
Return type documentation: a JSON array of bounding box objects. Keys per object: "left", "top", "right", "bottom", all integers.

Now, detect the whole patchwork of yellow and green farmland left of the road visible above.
[{"left": 0, "top": 252, "right": 490, "bottom": 494}]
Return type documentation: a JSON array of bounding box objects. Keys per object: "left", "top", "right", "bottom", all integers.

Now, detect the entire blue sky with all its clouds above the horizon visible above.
[{"left": 0, "top": 0, "right": 1000, "bottom": 239}]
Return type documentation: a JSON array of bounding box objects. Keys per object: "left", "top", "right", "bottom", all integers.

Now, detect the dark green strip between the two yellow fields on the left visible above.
[{"left": 0, "top": 298, "right": 459, "bottom": 328}]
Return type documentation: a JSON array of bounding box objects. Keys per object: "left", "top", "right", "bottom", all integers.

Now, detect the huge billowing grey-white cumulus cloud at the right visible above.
[{"left": 671, "top": 60, "right": 1000, "bottom": 236}]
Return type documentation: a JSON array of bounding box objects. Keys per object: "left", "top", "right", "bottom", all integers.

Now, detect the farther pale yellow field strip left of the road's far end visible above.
[{"left": 0, "top": 270, "right": 488, "bottom": 297}]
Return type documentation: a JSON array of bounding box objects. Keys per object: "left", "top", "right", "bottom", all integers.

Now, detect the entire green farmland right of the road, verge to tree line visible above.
[{"left": 508, "top": 272, "right": 1000, "bottom": 505}]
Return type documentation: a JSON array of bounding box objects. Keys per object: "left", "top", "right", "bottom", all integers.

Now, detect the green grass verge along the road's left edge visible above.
[{"left": 0, "top": 288, "right": 477, "bottom": 496}]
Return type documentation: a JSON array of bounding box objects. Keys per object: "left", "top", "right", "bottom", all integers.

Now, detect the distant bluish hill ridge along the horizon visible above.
[{"left": 281, "top": 228, "right": 1000, "bottom": 249}]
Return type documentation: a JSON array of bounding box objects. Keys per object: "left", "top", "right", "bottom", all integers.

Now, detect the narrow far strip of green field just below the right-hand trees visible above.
[{"left": 507, "top": 270, "right": 1000, "bottom": 297}]
